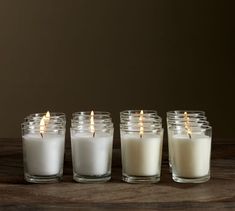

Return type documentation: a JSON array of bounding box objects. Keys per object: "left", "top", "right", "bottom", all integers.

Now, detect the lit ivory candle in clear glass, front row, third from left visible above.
[{"left": 120, "top": 110, "right": 163, "bottom": 183}]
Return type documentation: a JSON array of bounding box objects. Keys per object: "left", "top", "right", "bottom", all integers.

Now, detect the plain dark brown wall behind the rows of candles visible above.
[{"left": 0, "top": 0, "right": 235, "bottom": 141}]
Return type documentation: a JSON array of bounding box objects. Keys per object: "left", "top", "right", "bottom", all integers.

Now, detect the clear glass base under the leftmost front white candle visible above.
[{"left": 24, "top": 174, "right": 62, "bottom": 183}]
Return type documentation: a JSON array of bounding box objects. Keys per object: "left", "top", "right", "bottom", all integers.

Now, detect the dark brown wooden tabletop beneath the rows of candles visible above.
[{"left": 0, "top": 139, "right": 235, "bottom": 210}]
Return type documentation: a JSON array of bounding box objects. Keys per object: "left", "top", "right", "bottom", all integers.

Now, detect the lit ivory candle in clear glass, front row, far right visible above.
[{"left": 170, "top": 125, "right": 212, "bottom": 183}]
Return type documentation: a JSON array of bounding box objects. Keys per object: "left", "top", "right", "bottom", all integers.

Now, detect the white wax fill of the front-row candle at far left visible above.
[{"left": 23, "top": 133, "right": 65, "bottom": 176}]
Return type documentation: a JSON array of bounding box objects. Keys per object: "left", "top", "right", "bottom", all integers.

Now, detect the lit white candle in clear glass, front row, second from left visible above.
[{"left": 70, "top": 112, "right": 113, "bottom": 183}]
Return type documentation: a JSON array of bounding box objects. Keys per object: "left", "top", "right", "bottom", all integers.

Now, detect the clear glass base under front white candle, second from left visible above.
[{"left": 73, "top": 174, "right": 111, "bottom": 183}]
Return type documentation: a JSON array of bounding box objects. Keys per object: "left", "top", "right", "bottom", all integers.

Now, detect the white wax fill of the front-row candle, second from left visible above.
[{"left": 71, "top": 133, "right": 113, "bottom": 176}]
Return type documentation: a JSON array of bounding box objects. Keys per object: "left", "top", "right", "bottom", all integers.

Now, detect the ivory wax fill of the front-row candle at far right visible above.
[{"left": 171, "top": 134, "right": 211, "bottom": 178}]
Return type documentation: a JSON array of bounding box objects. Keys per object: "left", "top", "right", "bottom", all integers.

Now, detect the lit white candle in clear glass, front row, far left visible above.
[{"left": 21, "top": 113, "right": 65, "bottom": 183}]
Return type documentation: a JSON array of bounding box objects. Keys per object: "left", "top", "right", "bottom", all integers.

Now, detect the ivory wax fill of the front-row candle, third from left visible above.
[{"left": 121, "top": 134, "right": 162, "bottom": 176}]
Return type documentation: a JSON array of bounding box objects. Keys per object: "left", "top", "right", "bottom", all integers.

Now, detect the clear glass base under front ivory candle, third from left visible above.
[{"left": 122, "top": 175, "right": 160, "bottom": 183}]
